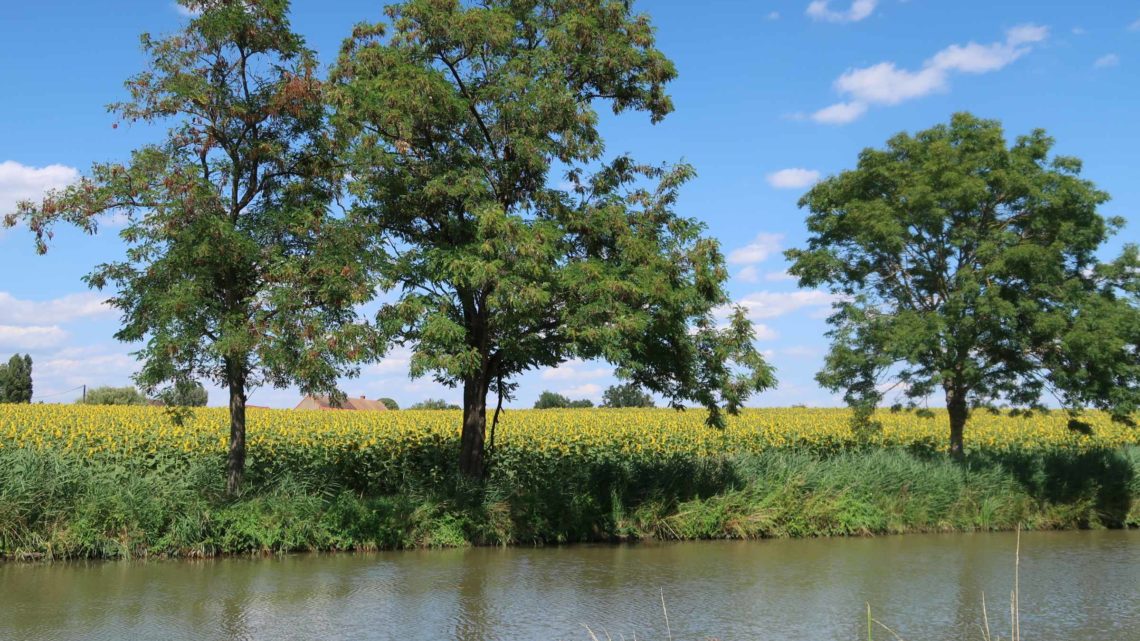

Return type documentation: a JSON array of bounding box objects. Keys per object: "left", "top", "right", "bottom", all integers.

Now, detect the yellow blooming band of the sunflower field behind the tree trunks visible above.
[{"left": 0, "top": 405, "right": 1140, "bottom": 461}]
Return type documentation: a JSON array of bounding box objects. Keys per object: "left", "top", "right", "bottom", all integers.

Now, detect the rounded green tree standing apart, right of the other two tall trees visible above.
[{"left": 787, "top": 114, "right": 1140, "bottom": 456}]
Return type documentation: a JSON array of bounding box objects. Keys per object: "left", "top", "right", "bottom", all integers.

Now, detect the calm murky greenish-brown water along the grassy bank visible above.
[{"left": 0, "top": 532, "right": 1140, "bottom": 641}]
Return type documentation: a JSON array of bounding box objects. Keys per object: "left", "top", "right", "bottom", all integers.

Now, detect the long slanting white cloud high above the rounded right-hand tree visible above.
[{"left": 812, "top": 24, "right": 1049, "bottom": 124}]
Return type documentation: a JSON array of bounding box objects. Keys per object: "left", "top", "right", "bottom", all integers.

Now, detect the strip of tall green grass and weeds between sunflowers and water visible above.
[{"left": 0, "top": 447, "right": 1140, "bottom": 559}]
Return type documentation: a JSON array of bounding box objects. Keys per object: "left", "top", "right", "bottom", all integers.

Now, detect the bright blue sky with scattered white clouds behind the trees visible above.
[{"left": 0, "top": 0, "right": 1140, "bottom": 406}]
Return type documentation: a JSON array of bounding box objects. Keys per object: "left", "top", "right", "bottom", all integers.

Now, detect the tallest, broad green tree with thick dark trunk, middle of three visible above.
[{"left": 333, "top": 0, "right": 772, "bottom": 477}]
